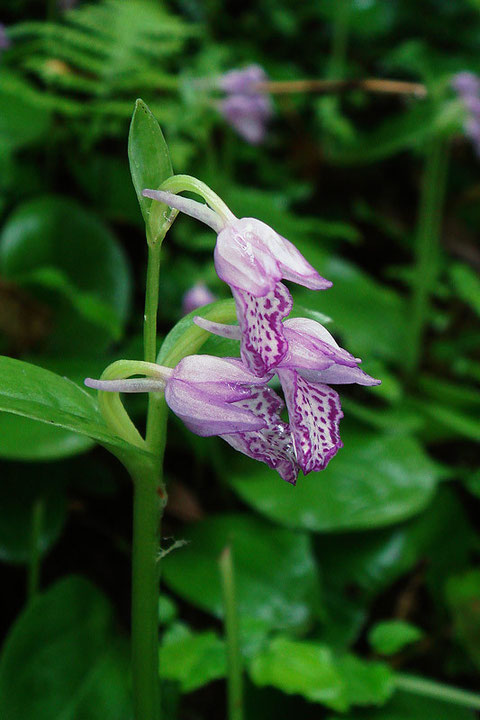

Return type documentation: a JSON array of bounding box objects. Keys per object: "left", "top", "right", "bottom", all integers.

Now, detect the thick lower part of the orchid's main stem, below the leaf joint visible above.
[{"left": 132, "top": 466, "right": 163, "bottom": 720}]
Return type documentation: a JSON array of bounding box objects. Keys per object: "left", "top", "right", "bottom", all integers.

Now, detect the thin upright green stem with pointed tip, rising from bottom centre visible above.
[{"left": 220, "top": 547, "right": 243, "bottom": 720}]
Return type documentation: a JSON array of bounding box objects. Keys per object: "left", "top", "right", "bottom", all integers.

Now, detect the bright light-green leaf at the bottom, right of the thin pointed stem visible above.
[{"left": 249, "top": 637, "right": 394, "bottom": 711}]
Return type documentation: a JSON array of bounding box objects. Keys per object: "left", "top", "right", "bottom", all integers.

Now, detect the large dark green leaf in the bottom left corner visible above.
[{"left": 0, "top": 577, "right": 131, "bottom": 720}]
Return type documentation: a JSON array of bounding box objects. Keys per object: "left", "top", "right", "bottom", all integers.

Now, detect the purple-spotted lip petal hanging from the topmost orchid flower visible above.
[{"left": 232, "top": 283, "right": 292, "bottom": 376}]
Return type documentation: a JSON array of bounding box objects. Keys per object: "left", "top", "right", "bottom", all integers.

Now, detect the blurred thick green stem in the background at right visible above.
[{"left": 405, "top": 138, "right": 448, "bottom": 381}]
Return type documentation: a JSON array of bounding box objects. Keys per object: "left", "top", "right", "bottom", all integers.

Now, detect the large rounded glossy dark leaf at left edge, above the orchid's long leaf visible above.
[{"left": 0, "top": 196, "right": 131, "bottom": 355}]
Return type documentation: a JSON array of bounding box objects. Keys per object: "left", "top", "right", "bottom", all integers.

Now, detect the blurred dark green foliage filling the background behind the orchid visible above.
[{"left": 0, "top": 0, "right": 480, "bottom": 720}]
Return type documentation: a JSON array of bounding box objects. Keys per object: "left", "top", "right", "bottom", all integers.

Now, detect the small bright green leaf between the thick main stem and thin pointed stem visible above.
[{"left": 160, "top": 623, "right": 226, "bottom": 693}]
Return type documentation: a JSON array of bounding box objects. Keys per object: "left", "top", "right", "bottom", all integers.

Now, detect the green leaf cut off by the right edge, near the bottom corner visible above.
[{"left": 446, "top": 570, "right": 480, "bottom": 668}]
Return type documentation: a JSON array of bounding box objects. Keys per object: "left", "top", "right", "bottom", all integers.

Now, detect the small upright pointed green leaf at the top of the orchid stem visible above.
[{"left": 128, "top": 100, "right": 173, "bottom": 241}]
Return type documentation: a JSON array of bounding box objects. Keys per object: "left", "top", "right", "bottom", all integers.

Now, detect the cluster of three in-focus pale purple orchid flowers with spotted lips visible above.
[{"left": 86, "top": 190, "right": 379, "bottom": 484}]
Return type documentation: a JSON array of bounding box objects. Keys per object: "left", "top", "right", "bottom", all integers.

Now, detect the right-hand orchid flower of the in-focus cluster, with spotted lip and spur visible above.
[{"left": 194, "top": 317, "right": 380, "bottom": 475}]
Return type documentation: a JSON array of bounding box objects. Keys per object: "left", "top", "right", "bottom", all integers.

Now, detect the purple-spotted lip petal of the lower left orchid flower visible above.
[{"left": 221, "top": 386, "right": 299, "bottom": 485}]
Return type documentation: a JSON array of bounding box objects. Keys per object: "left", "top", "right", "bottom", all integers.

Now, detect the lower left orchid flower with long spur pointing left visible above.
[{"left": 85, "top": 355, "right": 298, "bottom": 483}]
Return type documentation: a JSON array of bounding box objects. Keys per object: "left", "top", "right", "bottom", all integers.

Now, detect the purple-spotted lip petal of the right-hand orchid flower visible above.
[{"left": 278, "top": 369, "right": 343, "bottom": 475}]
